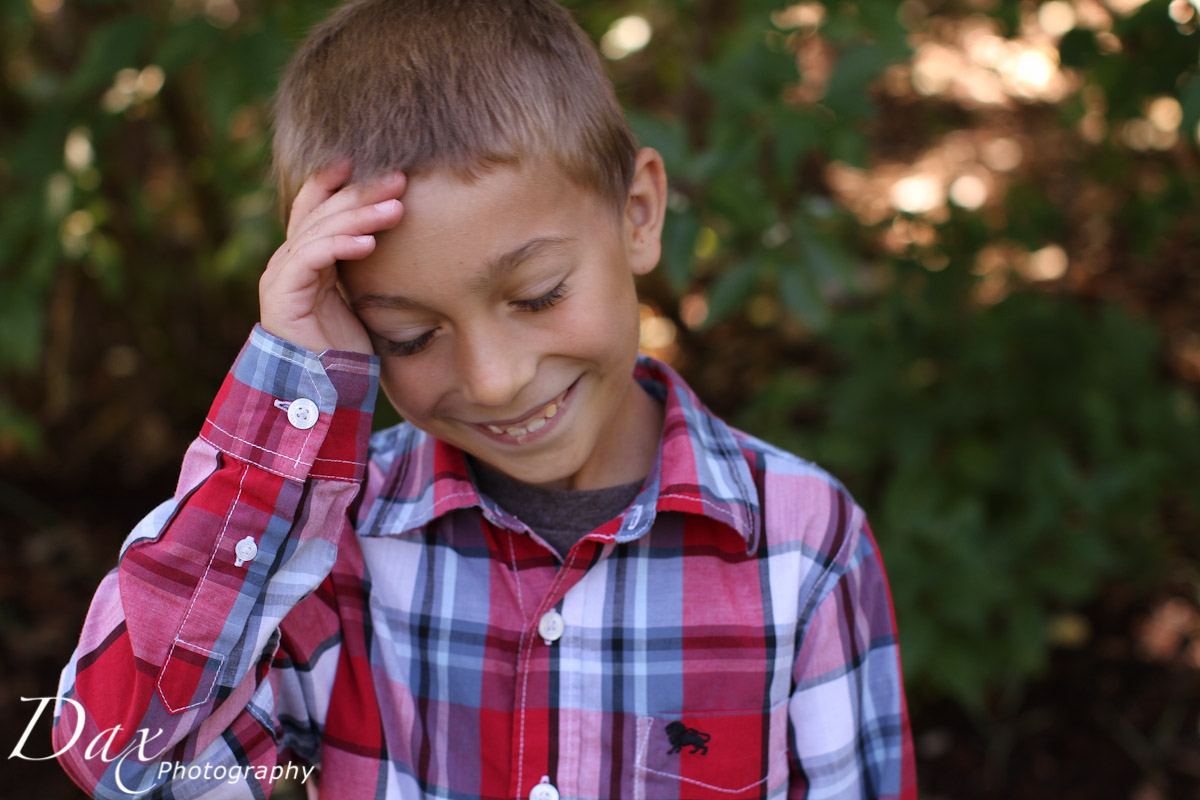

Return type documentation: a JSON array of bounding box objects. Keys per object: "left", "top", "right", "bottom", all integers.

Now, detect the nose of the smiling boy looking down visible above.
[{"left": 458, "top": 329, "right": 538, "bottom": 409}]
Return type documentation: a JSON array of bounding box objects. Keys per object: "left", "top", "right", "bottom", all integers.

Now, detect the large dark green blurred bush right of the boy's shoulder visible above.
[{"left": 739, "top": 275, "right": 1196, "bottom": 706}]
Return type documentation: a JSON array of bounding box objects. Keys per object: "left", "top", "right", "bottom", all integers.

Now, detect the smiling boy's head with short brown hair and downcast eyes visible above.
[{"left": 276, "top": 0, "right": 666, "bottom": 488}]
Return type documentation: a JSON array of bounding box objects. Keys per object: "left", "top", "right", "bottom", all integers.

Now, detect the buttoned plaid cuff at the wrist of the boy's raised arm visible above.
[{"left": 200, "top": 325, "right": 379, "bottom": 482}]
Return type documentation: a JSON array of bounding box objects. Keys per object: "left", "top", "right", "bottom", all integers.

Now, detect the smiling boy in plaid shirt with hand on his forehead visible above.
[{"left": 55, "top": 0, "right": 916, "bottom": 800}]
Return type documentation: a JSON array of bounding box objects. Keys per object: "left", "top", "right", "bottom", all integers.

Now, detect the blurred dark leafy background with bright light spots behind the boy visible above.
[{"left": 0, "top": 0, "right": 1200, "bottom": 800}]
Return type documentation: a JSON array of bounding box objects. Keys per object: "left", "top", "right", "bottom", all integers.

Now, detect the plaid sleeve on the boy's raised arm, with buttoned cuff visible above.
[{"left": 53, "top": 326, "right": 378, "bottom": 798}]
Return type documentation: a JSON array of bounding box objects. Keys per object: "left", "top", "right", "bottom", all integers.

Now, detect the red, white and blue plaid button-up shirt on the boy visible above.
[{"left": 54, "top": 329, "right": 916, "bottom": 800}]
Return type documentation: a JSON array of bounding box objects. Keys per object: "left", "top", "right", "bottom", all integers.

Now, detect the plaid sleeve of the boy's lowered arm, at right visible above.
[{"left": 788, "top": 512, "right": 917, "bottom": 800}]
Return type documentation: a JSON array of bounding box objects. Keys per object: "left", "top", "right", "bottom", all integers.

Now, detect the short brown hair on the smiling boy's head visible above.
[{"left": 274, "top": 0, "right": 637, "bottom": 218}]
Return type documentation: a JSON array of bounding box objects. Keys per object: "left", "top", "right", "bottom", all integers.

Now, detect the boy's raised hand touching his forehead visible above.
[{"left": 258, "top": 162, "right": 406, "bottom": 354}]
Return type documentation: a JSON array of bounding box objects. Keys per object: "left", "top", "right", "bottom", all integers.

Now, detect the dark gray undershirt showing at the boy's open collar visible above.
[{"left": 470, "top": 458, "right": 642, "bottom": 558}]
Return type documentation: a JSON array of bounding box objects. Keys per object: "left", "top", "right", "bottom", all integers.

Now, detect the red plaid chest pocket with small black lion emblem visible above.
[{"left": 631, "top": 699, "right": 787, "bottom": 800}]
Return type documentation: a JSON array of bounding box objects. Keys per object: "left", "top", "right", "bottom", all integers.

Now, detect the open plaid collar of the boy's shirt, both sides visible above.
[{"left": 359, "top": 355, "right": 762, "bottom": 552}]
